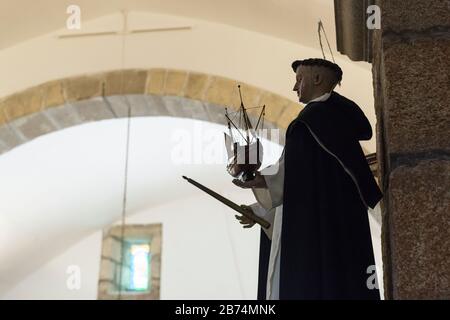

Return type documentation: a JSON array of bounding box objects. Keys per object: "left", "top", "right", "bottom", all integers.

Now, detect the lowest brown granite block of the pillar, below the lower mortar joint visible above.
[{"left": 389, "top": 160, "right": 450, "bottom": 299}]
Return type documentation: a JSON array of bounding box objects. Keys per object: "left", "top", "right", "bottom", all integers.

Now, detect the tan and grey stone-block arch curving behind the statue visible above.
[{"left": 0, "top": 69, "right": 300, "bottom": 154}]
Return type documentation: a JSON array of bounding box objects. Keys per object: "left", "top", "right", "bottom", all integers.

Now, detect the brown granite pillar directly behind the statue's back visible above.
[{"left": 373, "top": 0, "right": 450, "bottom": 299}]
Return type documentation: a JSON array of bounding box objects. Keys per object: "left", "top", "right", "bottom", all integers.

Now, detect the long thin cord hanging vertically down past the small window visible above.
[{"left": 118, "top": 11, "right": 131, "bottom": 300}]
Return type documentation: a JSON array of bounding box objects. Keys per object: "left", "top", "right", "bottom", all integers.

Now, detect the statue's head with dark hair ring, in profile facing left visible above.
[{"left": 292, "top": 58, "right": 342, "bottom": 103}]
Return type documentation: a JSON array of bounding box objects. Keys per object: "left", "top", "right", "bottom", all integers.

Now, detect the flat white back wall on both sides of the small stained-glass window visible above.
[{"left": 2, "top": 190, "right": 259, "bottom": 299}]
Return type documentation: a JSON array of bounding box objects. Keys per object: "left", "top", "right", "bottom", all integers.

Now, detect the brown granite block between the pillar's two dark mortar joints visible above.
[{"left": 383, "top": 39, "right": 450, "bottom": 153}]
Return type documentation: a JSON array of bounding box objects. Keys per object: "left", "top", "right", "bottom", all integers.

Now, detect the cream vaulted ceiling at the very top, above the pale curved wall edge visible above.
[{"left": 0, "top": 0, "right": 335, "bottom": 49}]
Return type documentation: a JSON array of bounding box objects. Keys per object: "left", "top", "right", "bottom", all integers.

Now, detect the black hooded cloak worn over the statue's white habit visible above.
[{"left": 258, "top": 92, "right": 382, "bottom": 299}]
